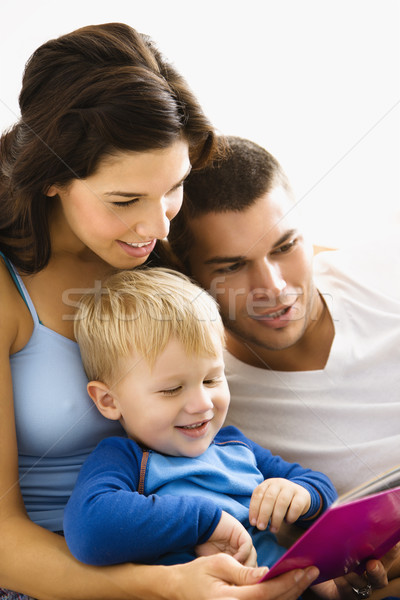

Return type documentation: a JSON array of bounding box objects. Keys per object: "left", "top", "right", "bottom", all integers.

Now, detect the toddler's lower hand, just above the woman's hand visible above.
[{"left": 195, "top": 510, "right": 257, "bottom": 567}]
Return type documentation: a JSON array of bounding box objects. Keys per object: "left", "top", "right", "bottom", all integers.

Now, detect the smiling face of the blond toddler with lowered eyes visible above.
[{"left": 107, "top": 339, "right": 230, "bottom": 457}]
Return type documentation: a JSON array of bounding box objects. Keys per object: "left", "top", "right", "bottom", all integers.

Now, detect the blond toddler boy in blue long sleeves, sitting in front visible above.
[{"left": 64, "top": 268, "right": 336, "bottom": 566}]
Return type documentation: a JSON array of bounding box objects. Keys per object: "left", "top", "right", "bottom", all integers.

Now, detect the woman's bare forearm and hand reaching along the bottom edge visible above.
[{"left": 0, "top": 519, "right": 317, "bottom": 600}]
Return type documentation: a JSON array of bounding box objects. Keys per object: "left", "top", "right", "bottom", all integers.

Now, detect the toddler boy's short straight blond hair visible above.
[{"left": 75, "top": 268, "right": 224, "bottom": 383}]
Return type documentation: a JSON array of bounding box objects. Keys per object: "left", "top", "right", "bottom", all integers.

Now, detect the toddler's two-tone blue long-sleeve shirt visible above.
[{"left": 64, "top": 427, "right": 336, "bottom": 566}]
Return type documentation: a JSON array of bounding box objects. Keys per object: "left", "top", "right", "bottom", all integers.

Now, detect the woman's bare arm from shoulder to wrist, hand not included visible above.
[{"left": 0, "top": 268, "right": 167, "bottom": 600}]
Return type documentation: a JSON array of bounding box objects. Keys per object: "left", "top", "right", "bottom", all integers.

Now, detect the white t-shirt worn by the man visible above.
[{"left": 225, "top": 245, "right": 400, "bottom": 493}]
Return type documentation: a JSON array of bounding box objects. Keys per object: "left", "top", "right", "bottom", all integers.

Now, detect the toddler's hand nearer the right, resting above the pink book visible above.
[{"left": 249, "top": 477, "right": 311, "bottom": 533}]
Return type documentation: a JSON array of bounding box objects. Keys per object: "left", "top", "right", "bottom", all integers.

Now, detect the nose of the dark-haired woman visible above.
[{"left": 135, "top": 197, "right": 182, "bottom": 240}]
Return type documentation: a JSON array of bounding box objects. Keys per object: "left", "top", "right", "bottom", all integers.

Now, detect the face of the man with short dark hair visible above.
[{"left": 185, "top": 187, "right": 316, "bottom": 358}]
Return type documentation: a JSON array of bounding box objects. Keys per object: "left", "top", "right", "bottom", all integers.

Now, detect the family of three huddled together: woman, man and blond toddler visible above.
[{"left": 0, "top": 23, "right": 400, "bottom": 600}]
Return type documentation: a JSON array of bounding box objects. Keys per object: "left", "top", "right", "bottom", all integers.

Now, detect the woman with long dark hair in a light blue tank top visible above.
[{"left": 0, "top": 24, "right": 317, "bottom": 600}]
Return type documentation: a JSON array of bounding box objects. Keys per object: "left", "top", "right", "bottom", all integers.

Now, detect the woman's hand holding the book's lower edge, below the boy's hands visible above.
[{"left": 169, "top": 553, "right": 318, "bottom": 600}]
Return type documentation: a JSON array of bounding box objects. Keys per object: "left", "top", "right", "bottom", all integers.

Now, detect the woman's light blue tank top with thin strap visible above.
[{"left": 0, "top": 253, "right": 124, "bottom": 531}]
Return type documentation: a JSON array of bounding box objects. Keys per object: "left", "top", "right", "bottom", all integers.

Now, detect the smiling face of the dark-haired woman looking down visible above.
[{"left": 47, "top": 140, "right": 190, "bottom": 269}]
